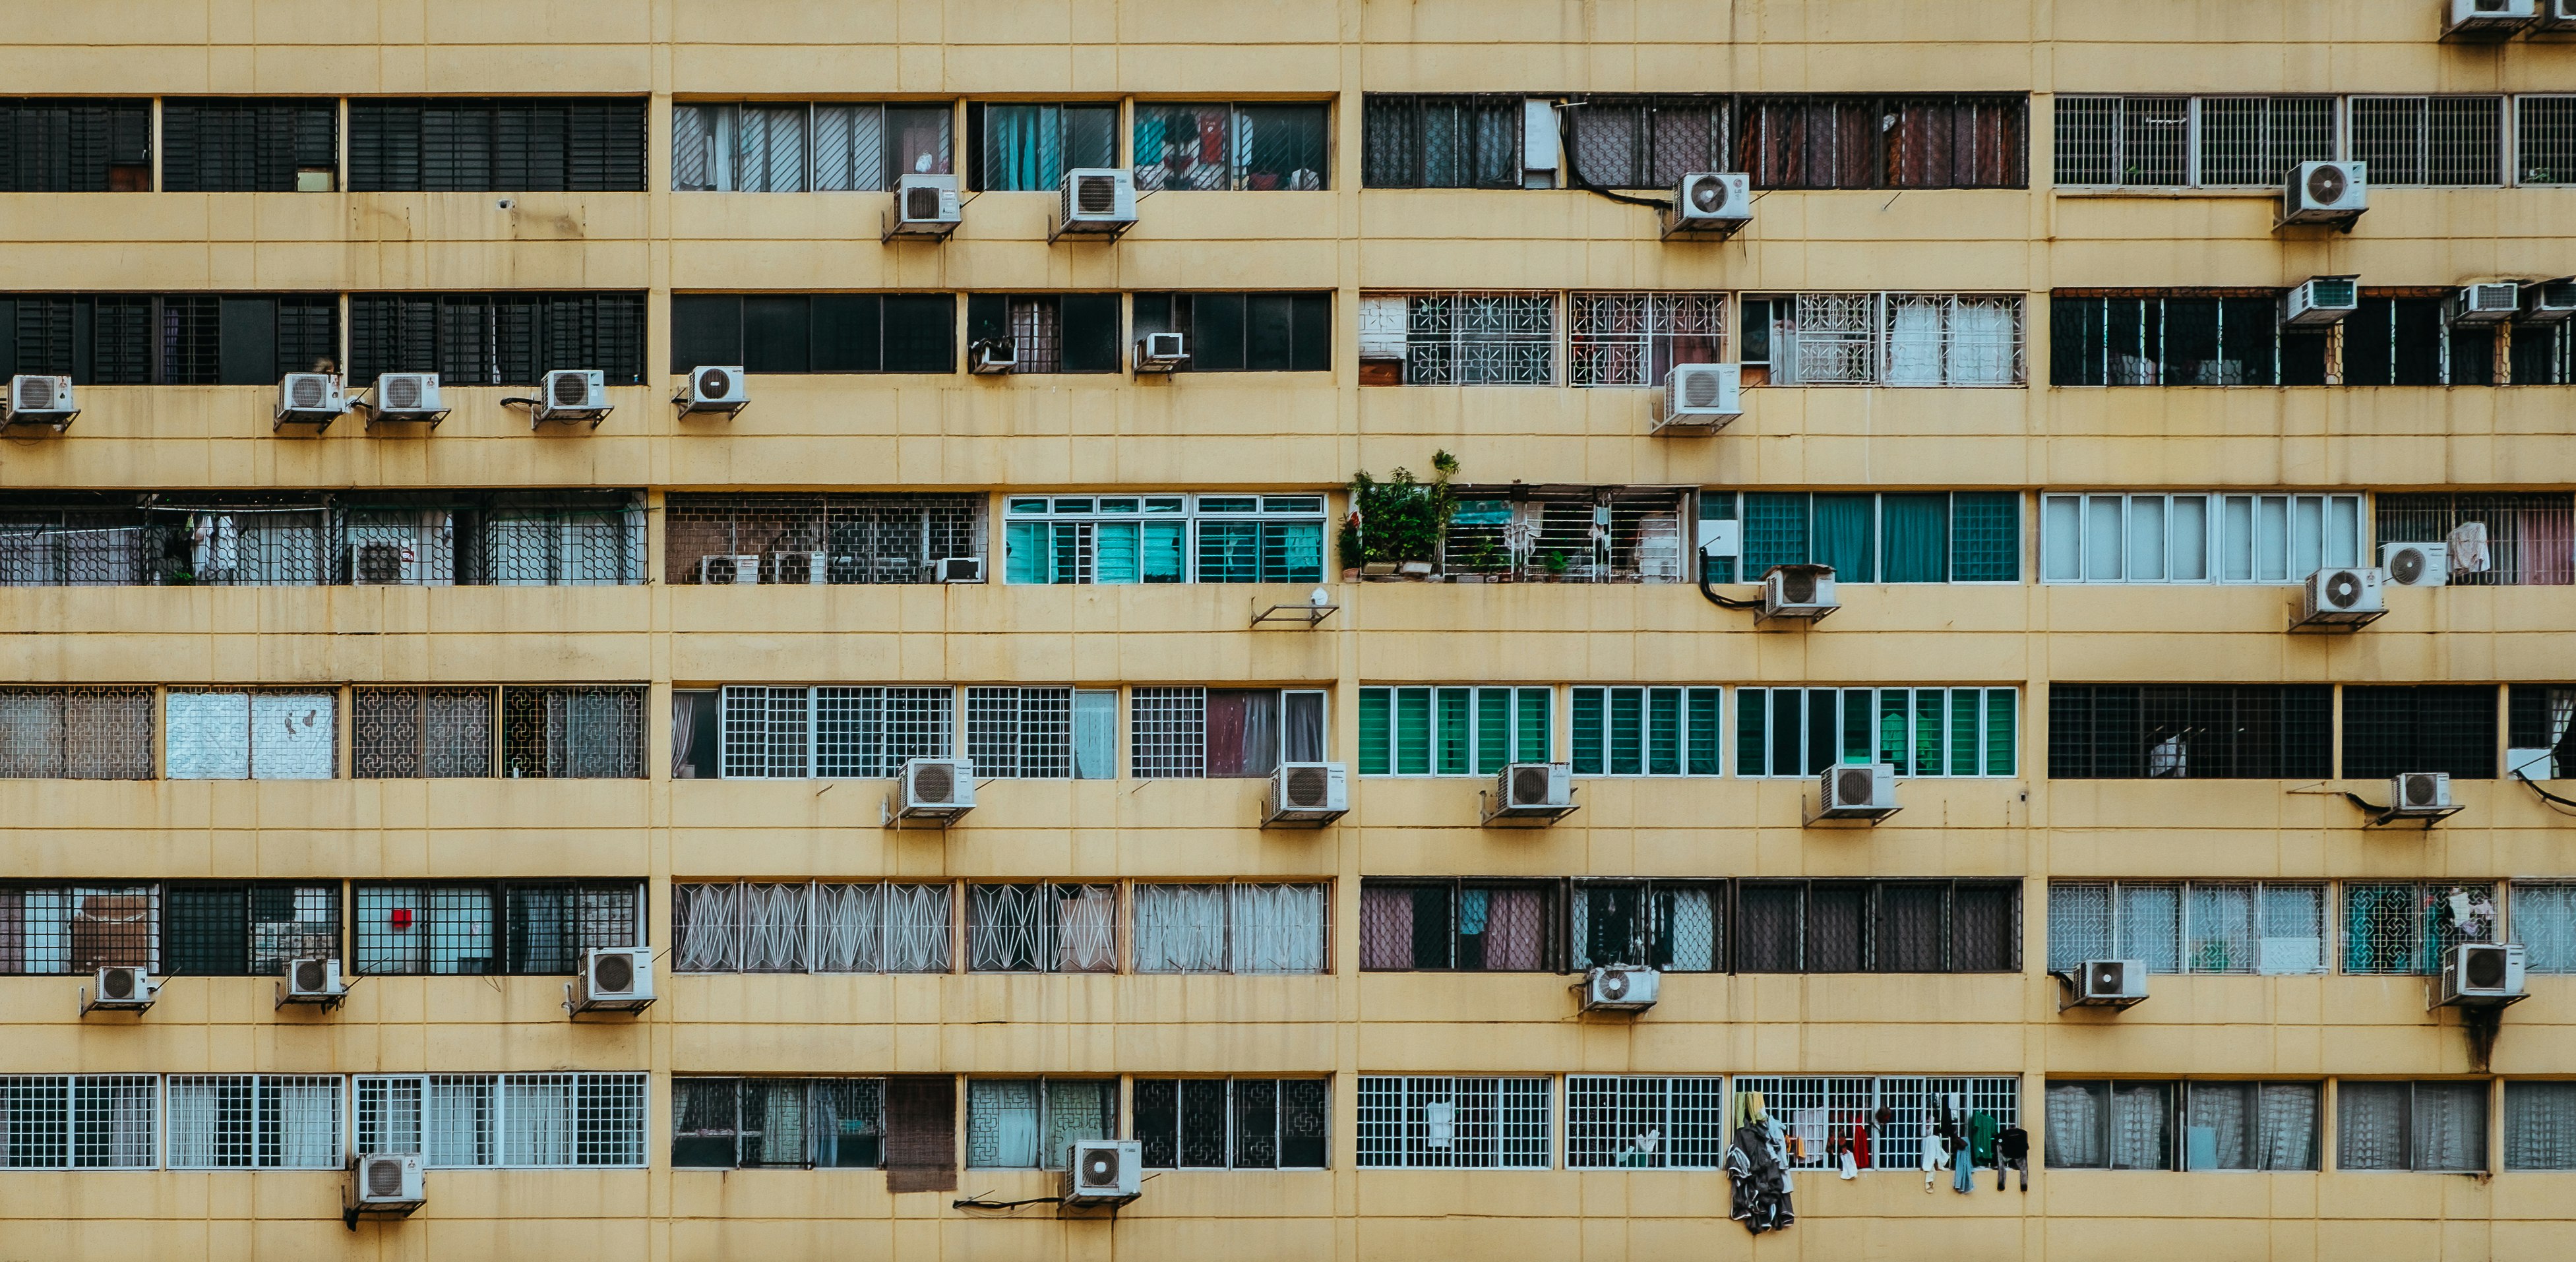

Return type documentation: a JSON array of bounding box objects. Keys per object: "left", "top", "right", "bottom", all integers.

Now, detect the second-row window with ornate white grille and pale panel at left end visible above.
[{"left": 1360, "top": 291, "right": 1556, "bottom": 386}]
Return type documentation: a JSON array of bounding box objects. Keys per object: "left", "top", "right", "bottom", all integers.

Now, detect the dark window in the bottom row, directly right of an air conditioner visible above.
[{"left": 1131, "top": 1079, "right": 1327, "bottom": 1169}]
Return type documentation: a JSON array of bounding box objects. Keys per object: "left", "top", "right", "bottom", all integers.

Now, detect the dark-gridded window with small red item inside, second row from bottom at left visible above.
[{"left": 353, "top": 881, "right": 644, "bottom": 973}]
